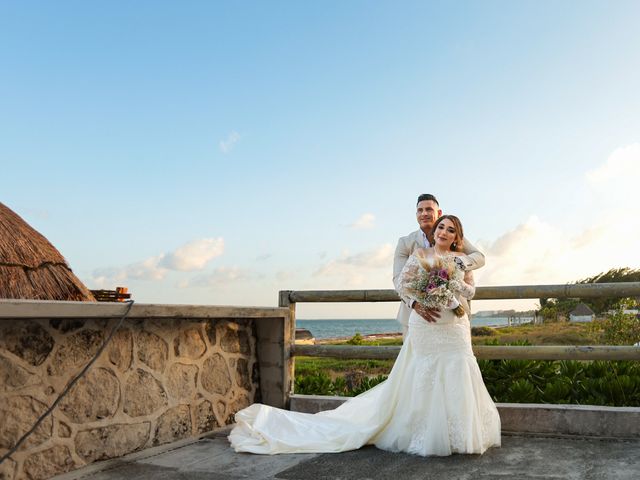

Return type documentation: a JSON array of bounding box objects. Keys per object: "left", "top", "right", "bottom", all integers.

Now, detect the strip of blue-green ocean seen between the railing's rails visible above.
[{"left": 296, "top": 317, "right": 532, "bottom": 339}]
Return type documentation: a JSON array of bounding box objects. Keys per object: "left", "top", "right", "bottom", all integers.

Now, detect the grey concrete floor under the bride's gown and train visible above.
[{"left": 55, "top": 432, "right": 640, "bottom": 480}]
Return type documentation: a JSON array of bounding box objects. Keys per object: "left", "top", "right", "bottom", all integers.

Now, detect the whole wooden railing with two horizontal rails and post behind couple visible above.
[{"left": 279, "top": 282, "right": 640, "bottom": 374}]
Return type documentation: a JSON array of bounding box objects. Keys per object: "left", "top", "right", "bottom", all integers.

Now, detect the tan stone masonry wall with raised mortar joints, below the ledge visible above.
[{"left": 0, "top": 318, "right": 259, "bottom": 480}]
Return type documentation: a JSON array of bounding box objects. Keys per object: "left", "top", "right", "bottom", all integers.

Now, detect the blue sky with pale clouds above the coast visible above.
[{"left": 0, "top": 0, "right": 640, "bottom": 318}]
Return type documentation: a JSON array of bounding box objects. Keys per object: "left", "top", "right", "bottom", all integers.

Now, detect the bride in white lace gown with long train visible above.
[{"left": 229, "top": 215, "right": 500, "bottom": 456}]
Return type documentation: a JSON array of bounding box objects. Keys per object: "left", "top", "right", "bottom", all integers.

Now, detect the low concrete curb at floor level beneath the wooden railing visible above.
[{"left": 290, "top": 395, "right": 640, "bottom": 439}]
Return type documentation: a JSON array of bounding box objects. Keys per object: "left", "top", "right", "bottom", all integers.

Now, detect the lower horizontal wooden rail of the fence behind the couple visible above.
[{"left": 292, "top": 345, "right": 640, "bottom": 360}]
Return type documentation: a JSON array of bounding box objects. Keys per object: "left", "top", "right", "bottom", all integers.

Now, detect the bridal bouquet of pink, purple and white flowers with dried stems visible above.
[{"left": 404, "top": 256, "right": 465, "bottom": 317}]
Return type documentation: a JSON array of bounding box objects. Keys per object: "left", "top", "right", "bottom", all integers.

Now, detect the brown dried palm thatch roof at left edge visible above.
[{"left": 0, "top": 202, "right": 95, "bottom": 302}]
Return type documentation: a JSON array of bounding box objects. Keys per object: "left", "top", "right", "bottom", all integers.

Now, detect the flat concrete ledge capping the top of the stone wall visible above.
[{"left": 0, "top": 300, "right": 289, "bottom": 320}]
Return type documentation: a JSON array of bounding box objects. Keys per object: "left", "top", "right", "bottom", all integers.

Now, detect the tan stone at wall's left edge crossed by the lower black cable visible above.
[{"left": 0, "top": 396, "right": 53, "bottom": 449}]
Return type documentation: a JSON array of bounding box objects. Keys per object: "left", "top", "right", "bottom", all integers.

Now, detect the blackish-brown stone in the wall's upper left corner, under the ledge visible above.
[{"left": 0, "top": 321, "right": 53, "bottom": 366}]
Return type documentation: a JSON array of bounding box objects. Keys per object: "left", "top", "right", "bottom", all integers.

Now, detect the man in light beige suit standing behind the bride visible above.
[{"left": 393, "top": 193, "right": 484, "bottom": 335}]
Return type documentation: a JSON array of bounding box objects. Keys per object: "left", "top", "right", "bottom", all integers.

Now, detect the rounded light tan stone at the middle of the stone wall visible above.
[{"left": 123, "top": 369, "right": 167, "bottom": 417}]
